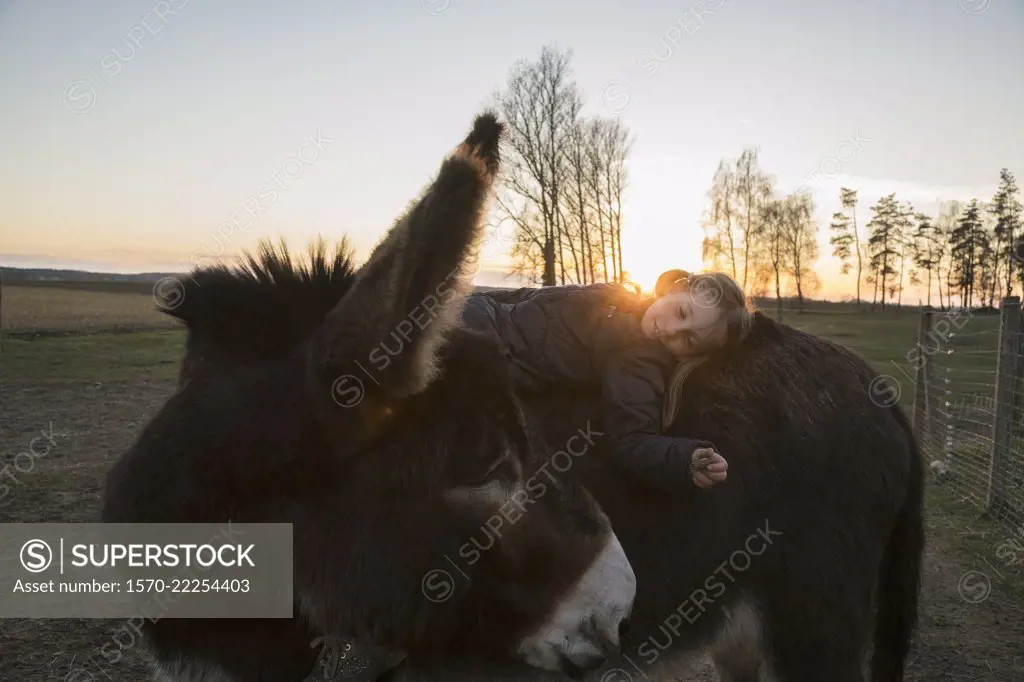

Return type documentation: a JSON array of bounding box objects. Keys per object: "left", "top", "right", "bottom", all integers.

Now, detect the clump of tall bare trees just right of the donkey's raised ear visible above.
[{"left": 496, "top": 47, "right": 632, "bottom": 286}]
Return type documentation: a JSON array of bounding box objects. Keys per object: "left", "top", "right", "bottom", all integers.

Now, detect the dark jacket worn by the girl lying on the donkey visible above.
[{"left": 463, "top": 284, "right": 712, "bottom": 491}]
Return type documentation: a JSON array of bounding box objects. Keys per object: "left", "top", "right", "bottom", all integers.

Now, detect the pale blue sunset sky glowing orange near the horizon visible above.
[{"left": 0, "top": 0, "right": 1024, "bottom": 297}]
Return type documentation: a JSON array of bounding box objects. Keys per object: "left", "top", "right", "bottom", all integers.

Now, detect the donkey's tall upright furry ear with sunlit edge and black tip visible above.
[{"left": 307, "top": 113, "right": 504, "bottom": 430}]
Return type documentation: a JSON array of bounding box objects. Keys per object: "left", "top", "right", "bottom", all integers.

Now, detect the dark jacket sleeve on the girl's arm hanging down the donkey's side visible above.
[{"left": 601, "top": 351, "right": 714, "bottom": 492}]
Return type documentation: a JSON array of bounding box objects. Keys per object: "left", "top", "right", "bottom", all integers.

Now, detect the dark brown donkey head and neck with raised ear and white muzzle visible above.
[{"left": 102, "top": 114, "right": 636, "bottom": 682}]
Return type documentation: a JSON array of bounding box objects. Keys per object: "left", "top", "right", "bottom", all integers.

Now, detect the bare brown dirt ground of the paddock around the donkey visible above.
[{"left": 0, "top": 374, "right": 1024, "bottom": 682}]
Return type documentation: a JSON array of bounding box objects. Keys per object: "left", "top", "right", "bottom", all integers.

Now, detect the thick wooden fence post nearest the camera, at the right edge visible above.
[{"left": 985, "top": 296, "right": 1021, "bottom": 515}]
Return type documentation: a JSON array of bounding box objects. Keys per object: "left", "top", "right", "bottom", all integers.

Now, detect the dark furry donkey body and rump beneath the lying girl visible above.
[{"left": 387, "top": 313, "right": 924, "bottom": 682}]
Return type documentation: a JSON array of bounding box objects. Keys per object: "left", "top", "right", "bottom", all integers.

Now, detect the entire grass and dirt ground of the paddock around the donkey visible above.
[{"left": 0, "top": 283, "right": 1024, "bottom": 682}]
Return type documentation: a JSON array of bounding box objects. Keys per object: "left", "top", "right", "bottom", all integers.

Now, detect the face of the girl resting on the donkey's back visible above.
[{"left": 640, "top": 291, "right": 726, "bottom": 357}]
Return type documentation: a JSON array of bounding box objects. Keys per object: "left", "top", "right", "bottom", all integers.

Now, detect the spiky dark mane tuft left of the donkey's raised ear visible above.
[{"left": 164, "top": 239, "right": 356, "bottom": 357}]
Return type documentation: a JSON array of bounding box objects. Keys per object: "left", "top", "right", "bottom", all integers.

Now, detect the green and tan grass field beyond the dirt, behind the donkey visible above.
[{"left": 0, "top": 283, "right": 998, "bottom": 407}]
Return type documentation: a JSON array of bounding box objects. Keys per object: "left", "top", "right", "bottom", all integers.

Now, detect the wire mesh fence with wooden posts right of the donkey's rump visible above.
[{"left": 913, "top": 297, "right": 1024, "bottom": 535}]
